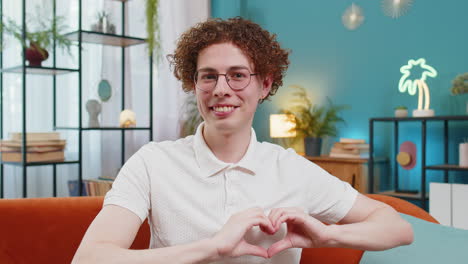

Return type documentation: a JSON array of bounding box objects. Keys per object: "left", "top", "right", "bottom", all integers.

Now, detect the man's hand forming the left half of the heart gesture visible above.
[{"left": 212, "top": 208, "right": 277, "bottom": 258}]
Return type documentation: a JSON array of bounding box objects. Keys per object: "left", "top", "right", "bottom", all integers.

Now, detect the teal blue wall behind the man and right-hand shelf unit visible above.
[{"left": 212, "top": 0, "right": 468, "bottom": 189}]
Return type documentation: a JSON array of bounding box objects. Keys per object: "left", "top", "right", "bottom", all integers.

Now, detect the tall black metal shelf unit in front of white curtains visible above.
[{"left": 0, "top": 0, "right": 153, "bottom": 198}]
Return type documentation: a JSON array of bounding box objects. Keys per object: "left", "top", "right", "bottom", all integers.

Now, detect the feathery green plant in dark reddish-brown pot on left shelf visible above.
[{"left": 0, "top": 16, "right": 73, "bottom": 67}]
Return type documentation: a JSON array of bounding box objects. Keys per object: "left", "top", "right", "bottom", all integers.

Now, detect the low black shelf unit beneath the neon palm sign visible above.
[{"left": 368, "top": 115, "right": 468, "bottom": 209}]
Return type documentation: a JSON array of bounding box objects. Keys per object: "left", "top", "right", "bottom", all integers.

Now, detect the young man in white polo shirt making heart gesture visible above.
[{"left": 74, "top": 18, "right": 413, "bottom": 264}]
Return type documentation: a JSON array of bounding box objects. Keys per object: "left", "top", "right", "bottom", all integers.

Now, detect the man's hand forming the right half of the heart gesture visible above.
[{"left": 268, "top": 207, "right": 329, "bottom": 257}]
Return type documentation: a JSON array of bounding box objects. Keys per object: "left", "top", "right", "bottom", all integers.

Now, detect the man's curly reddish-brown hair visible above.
[{"left": 167, "top": 17, "right": 290, "bottom": 100}]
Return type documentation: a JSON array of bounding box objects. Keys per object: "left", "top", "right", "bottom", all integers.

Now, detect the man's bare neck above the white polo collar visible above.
[{"left": 203, "top": 126, "right": 251, "bottom": 163}]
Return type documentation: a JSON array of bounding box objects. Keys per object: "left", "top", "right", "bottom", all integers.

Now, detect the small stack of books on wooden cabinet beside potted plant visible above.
[{"left": 330, "top": 138, "right": 369, "bottom": 159}]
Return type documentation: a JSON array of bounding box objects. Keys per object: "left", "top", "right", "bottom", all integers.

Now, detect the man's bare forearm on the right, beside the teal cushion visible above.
[{"left": 324, "top": 207, "right": 413, "bottom": 250}]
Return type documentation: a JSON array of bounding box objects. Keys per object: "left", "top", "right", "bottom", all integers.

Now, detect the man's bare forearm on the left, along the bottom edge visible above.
[{"left": 72, "top": 239, "right": 218, "bottom": 264}]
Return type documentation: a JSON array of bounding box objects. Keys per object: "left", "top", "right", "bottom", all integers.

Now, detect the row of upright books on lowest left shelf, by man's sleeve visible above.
[{"left": 68, "top": 176, "right": 114, "bottom": 196}]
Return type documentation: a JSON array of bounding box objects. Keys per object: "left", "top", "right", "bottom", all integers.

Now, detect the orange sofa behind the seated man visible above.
[{"left": 0, "top": 194, "right": 437, "bottom": 264}]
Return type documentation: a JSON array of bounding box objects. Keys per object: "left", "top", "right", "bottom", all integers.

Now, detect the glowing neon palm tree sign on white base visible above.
[{"left": 398, "top": 58, "right": 437, "bottom": 117}]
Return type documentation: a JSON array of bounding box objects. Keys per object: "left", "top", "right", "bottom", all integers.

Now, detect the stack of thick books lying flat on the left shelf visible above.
[{"left": 0, "top": 132, "right": 66, "bottom": 162}]
